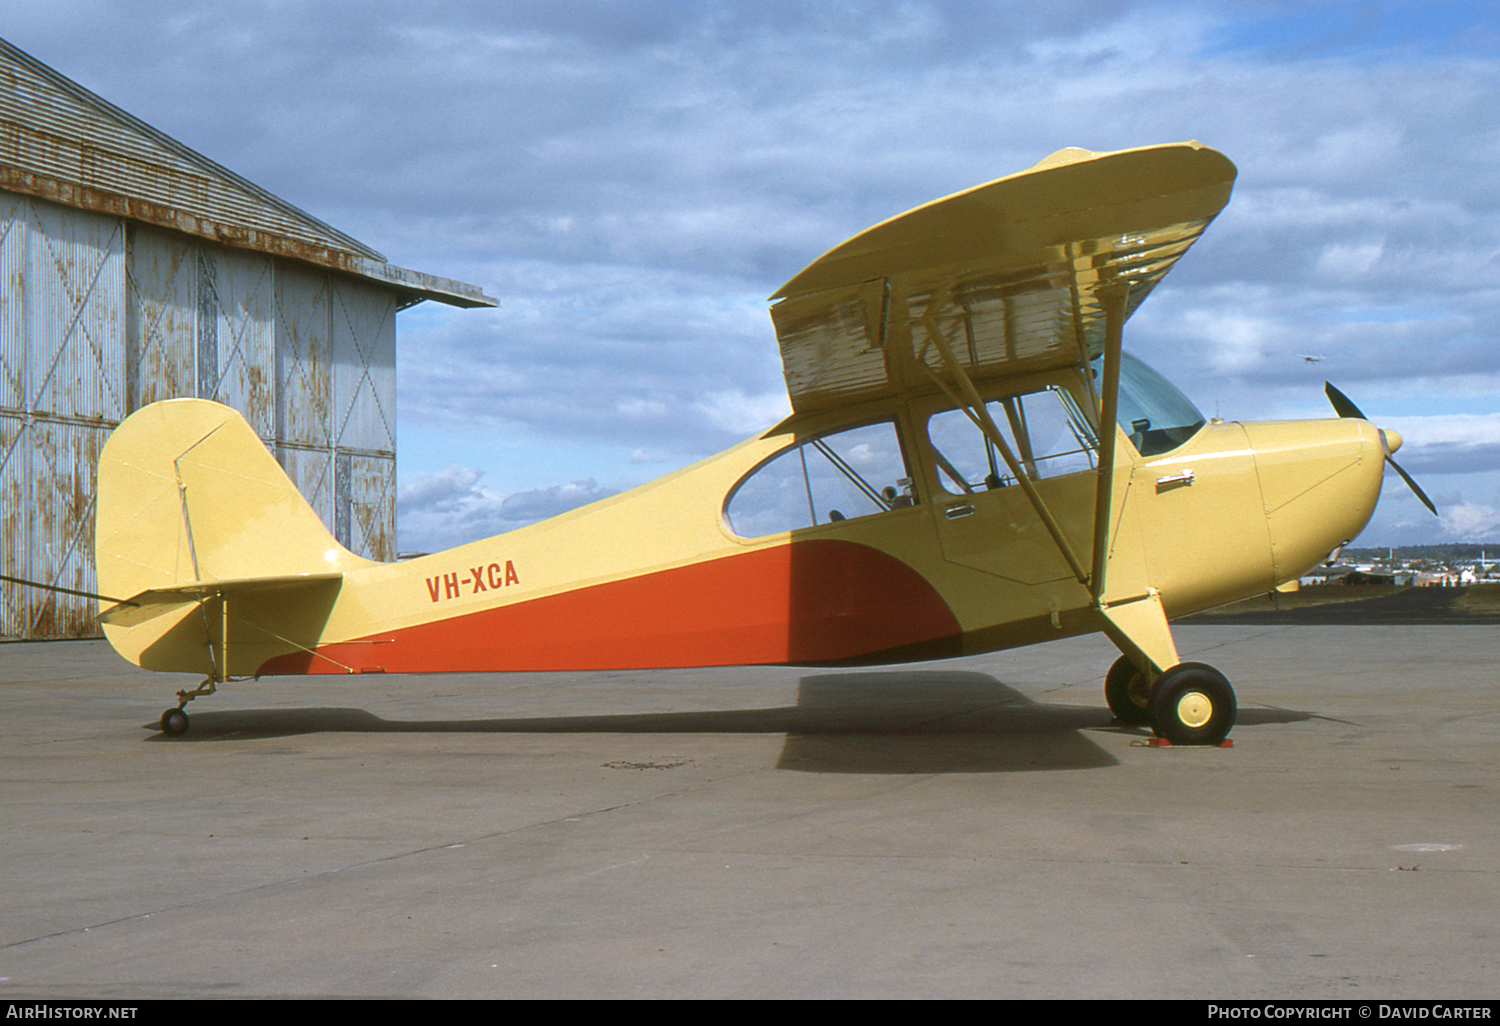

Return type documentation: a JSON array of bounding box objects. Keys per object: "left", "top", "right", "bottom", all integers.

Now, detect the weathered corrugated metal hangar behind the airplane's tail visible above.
[{"left": 0, "top": 39, "right": 495, "bottom": 639}]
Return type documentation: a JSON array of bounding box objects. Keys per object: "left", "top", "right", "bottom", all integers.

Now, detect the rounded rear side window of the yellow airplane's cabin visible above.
[{"left": 725, "top": 420, "right": 917, "bottom": 539}]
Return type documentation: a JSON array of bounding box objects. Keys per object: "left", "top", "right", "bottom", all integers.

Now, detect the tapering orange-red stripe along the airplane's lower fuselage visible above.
[{"left": 260, "top": 540, "right": 962, "bottom": 675}]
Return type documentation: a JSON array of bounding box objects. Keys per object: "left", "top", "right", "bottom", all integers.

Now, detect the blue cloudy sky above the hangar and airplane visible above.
[{"left": 0, "top": 0, "right": 1500, "bottom": 551}]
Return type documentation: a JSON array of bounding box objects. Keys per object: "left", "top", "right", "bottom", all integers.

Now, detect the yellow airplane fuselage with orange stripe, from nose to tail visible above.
[{"left": 105, "top": 360, "right": 1382, "bottom": 675}]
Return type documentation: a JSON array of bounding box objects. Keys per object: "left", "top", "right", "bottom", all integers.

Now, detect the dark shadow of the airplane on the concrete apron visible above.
[{"left": 138, "top": 671, "right": 1310, "bottom": 774}]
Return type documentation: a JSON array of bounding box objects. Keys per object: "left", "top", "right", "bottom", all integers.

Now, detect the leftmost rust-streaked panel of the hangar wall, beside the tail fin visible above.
[{"left": 0, "top": 194, "right": 126, "bottom": 638}]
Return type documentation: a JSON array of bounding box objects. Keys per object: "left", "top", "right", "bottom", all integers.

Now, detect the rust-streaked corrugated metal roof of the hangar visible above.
[{"left": 0, "top": 39, "right": 498, "bottom": 306}]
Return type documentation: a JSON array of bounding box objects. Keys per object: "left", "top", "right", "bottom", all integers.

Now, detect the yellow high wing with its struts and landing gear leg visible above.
[{"left": 771, "top": 143, "right": 1236, "bottom": 669}]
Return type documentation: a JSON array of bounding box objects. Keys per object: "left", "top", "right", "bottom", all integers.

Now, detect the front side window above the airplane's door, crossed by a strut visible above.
[{"left": 927, "top": 386, "right": 1100, "bottom": 495}]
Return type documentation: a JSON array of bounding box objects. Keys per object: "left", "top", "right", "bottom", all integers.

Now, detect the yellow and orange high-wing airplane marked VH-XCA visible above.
[{"left": 96, "top": 143, "right": 1431, "bottom": 744}]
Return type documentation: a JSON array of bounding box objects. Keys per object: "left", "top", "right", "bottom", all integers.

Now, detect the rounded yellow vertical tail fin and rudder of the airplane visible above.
[{"left": 95, "top": 399, "right": 368, "bottom": 677}]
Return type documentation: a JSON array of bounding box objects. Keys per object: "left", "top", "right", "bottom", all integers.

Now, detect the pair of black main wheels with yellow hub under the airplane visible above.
[{"left": 1104, "top": 656, "right": 1239, "bottom": 746}]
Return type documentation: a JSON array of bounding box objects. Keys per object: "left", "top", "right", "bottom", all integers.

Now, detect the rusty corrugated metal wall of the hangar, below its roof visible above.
[{"left": 0, "top": 192, "right": 396, "bottom": 638}]
